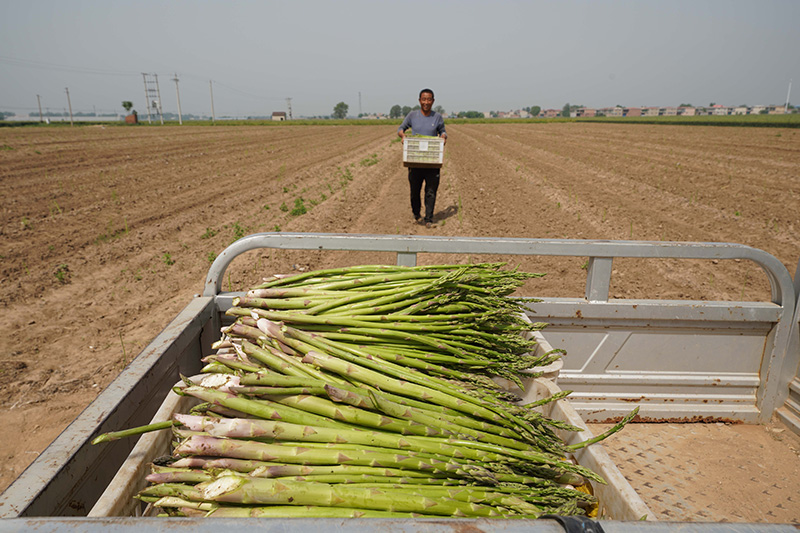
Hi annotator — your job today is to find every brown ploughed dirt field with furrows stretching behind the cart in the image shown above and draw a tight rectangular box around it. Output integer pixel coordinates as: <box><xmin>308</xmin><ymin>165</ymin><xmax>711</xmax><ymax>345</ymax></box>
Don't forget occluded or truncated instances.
<box><xmin>0</xmin><ymin>123</ymin><xmax>800</xmax><ymax>521</ymax></box>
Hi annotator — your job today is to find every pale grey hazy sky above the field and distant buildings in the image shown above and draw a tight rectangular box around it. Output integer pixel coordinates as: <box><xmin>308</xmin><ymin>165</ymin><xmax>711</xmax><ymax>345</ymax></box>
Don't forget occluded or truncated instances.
<box><xmin>0</xmin><ymin>0</ymin><xmax>800</xmax><ymax>117</ymax></box>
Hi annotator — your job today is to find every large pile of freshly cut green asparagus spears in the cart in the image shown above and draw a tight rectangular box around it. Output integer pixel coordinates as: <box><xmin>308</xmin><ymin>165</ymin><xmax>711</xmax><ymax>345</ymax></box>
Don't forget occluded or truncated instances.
<box><xmin>95</xmin><ymin>264</ymin><xmax>635</xmax><ymax>518</ymax></box>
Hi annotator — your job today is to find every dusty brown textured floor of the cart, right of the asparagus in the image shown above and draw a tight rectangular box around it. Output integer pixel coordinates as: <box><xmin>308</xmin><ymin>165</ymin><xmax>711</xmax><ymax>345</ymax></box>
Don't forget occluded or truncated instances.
<box><xmin>588</xmin><ymin>421</ymin><xmax>800</xmax><ymax>525</ymax></box>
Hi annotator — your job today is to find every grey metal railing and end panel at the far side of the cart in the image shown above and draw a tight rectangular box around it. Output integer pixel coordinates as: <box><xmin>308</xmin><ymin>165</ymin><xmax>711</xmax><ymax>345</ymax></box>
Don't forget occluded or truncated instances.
<box><xmin>204</xmin><ymin>233</ymin><xmax>795</xmax><ymax>422</ymax></box>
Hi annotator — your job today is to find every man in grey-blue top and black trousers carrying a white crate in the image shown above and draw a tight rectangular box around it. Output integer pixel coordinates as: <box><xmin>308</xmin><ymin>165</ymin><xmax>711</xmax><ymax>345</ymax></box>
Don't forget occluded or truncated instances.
<box><xmin>397</xmin><ymin>89</ymin><xmax>447</xmax><ymax>228</ymax></box>
